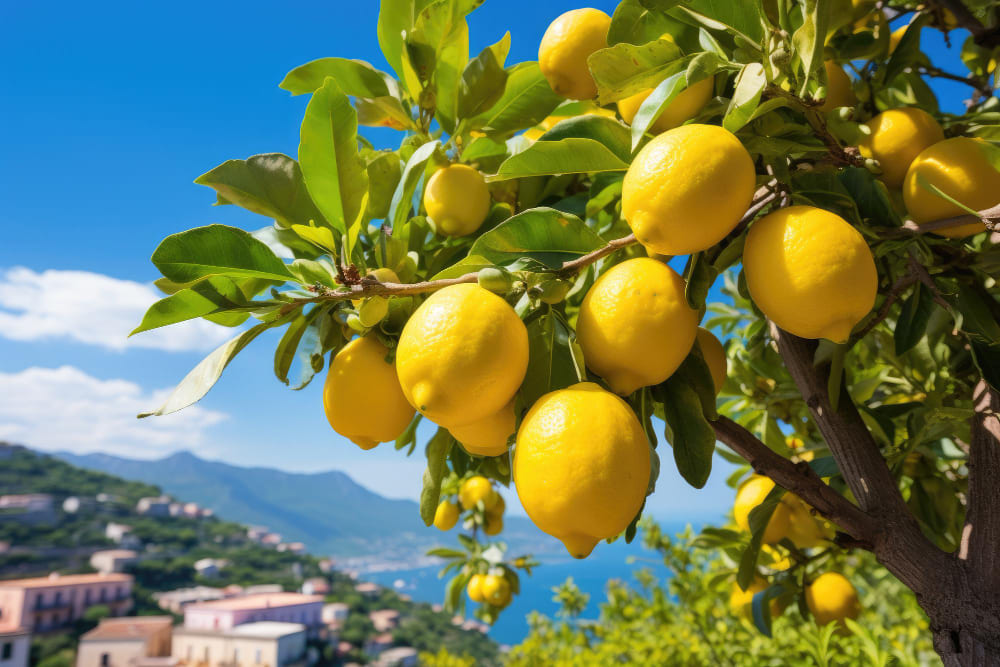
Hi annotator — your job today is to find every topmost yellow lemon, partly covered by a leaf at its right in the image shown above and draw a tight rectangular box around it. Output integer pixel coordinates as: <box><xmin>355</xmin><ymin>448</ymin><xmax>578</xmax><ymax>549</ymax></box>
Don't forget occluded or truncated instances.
<box><xmin>538</xmin><ymin>7</ymin><xmax>611</xmax><ymax>100</ymax></box>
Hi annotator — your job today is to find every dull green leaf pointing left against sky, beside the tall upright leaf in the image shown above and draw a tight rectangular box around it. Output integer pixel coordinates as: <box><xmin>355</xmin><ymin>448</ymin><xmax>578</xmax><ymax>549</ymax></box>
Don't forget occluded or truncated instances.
<box><xmin>194</xmin><ymin>153</ymin><xmax>325</xmax><ymax>227</ymax></box>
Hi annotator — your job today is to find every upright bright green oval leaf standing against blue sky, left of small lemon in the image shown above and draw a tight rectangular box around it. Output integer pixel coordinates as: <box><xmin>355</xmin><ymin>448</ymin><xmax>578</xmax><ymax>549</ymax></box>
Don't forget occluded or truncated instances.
<box><xmin>299</xmin><ymin>77</ymin><xmax>368</xmax><ymax>243</ymax></box>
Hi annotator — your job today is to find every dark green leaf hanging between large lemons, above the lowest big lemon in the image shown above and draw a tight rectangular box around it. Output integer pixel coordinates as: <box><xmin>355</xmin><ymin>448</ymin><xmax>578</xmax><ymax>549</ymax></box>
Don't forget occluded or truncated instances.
<box><xmin>521</xmin><ymin>310</ymin><xmax>580</xmax><ymax>405</ymax></box>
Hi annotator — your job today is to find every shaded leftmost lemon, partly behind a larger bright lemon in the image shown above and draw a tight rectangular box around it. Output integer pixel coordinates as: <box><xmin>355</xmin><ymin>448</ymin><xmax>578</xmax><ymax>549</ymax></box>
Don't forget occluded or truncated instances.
<box><xmin>323</xmin><ymin>336</ymin><xmax>413</xmax><ymax>449</ymax></box>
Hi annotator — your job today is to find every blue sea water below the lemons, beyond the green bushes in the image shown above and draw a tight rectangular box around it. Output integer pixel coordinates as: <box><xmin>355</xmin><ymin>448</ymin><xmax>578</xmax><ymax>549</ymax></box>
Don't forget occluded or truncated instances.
<box><xmin>362</xmin><ymin>522</ymin><xmax>701</xmax><ymax>645</ymax></box>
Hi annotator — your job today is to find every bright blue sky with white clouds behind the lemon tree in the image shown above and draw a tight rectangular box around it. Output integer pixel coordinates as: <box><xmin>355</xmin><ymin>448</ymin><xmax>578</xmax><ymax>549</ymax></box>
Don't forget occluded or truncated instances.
<box><xmin>0</xmin><ymin>0</ymin><xmax>968</xmax><ymax>519</ymax></box>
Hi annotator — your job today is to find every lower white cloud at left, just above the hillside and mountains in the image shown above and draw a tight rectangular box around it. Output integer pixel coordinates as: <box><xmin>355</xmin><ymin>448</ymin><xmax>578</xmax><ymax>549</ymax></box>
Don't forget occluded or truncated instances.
<box><xmin>0</xmin><ymin>366</ymin><xmax>226</xmax><ymax>458</ymax></box>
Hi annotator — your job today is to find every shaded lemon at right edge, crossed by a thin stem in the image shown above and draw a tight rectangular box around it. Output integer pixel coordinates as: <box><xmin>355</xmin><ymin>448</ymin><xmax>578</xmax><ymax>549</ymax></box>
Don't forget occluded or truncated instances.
<box><xmin>903</xmin><ymin>137</ymin><xmax>1000</xmax><ymax>239</ymax></box>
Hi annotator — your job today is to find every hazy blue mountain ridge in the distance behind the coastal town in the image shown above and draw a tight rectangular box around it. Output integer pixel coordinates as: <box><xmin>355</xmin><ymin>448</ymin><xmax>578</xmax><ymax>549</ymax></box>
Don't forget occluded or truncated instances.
<box><xmin>56</xmin><ymin>452</ymin><xmax>547</xmax><ymax>561</ymax></box>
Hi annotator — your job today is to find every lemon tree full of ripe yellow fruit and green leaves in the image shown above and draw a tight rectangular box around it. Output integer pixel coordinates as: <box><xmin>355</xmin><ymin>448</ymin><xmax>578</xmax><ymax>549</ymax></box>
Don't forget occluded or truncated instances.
<box><xmin>134</xmin><ymin>0</ymin><xmax>1000</xmax><ymax>664</ymax></box>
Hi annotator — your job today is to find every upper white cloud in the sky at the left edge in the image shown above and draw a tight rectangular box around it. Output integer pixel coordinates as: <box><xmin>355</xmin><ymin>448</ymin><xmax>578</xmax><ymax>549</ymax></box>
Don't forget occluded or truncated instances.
<box><xmin>0</xmin><ymin>267</ymin><xmax>235</xmax><ymax>351</ymax></box>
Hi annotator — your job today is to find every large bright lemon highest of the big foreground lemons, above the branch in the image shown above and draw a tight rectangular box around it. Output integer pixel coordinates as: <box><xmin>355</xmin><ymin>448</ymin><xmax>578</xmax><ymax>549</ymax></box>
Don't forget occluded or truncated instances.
<box><xmin>622</xmin><ymin>123</ymin><xmax>755</xmax><ymax>255</ymax></box>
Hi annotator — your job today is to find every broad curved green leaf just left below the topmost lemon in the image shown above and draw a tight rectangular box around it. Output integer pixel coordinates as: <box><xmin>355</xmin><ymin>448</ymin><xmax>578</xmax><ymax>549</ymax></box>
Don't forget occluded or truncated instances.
<box><xmin>468</xmin><ymin>61</ymin><xmax>562</xmax><ymax>135</ymax></box>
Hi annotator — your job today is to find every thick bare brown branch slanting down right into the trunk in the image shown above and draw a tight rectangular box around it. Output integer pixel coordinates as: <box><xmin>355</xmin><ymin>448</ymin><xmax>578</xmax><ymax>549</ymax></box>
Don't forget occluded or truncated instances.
<box><xmin>712</xmin><ymin>417</ymin><xmax>878</xmax><ymax>549</ymax></box>
